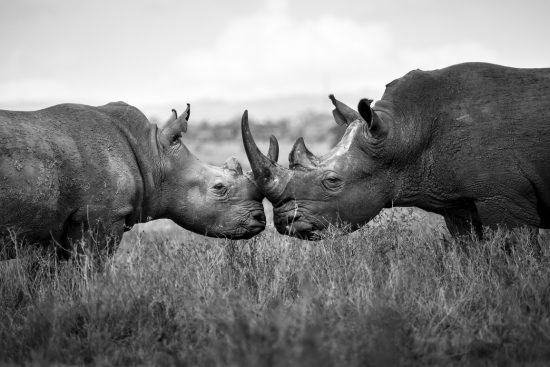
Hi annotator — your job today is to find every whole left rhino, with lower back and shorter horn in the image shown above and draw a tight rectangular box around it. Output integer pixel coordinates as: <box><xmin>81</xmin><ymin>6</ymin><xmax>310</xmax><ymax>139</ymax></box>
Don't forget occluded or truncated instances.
<box><xmin>0</xmin><ymin>102</ymin><xmax>265</xmax><ymax>255</ymax></box>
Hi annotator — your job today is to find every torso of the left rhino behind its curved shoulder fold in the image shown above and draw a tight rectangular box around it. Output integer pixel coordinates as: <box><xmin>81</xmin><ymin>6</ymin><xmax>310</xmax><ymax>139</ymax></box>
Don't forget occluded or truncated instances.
<box><xmin>0</xmin><ymin>104</ymin><xmax>141</xmax><ymax>239</ymax></box>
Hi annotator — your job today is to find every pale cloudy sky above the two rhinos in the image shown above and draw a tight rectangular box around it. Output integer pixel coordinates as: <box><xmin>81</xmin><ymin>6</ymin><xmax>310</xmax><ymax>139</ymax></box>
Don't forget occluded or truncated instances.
<box><xmin>0</xmin><ymin>0</ymin><xmax>550</xmax><ymax>118</ymax></box>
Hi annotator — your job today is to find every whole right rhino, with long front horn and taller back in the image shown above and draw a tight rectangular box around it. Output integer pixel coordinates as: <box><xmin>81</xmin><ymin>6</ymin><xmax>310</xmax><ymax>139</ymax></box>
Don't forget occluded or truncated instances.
<box><xmin>246</xmin><ymin>63</ymin><xmax>550</xmax><ymax>239</ymax></box>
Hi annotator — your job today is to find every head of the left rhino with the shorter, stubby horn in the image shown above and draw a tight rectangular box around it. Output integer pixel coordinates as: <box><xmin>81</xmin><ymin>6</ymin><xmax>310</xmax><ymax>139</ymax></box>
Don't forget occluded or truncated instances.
<box><xmin>155</xmin><ymin>106</ymin><xmax>265</xmax><ymax>239</ymax></box>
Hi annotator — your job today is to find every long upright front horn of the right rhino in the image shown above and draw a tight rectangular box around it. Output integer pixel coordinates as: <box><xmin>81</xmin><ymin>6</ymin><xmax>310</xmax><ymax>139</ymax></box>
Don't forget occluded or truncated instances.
<box><xmin>241</xmin><ymin>110</ymin><xmax>292</xmax><ymax>201</ymax></box>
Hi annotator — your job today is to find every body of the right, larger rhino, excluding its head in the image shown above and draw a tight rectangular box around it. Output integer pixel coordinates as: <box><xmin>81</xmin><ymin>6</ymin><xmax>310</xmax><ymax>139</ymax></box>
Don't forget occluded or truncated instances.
<box><xmin>374</xmin><ymin>63</ymin><xmax>550</xmax><ymax>234</ymax></box>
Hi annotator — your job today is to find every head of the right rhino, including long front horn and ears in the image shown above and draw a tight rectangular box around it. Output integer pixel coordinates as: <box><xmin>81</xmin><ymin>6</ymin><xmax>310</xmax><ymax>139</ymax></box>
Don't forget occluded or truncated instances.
<box><xmin>241</xmin><ymin>95</ymin><xmax>393</xmax><ymax>240</ymax></box>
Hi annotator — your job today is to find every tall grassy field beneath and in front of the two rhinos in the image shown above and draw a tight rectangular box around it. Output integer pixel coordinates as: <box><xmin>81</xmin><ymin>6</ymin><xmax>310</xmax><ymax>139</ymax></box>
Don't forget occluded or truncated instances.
<box><xmin>0</xmin><ymin>211</ymin><xmax>550</xmax><ymax>366</ymax></box>
